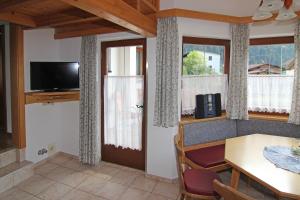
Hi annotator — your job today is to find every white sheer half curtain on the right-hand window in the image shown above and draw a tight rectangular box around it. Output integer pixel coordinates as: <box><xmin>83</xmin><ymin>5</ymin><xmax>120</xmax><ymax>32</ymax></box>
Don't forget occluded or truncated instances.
<box><xmin>248</xmin><ymin>75</ymin><xmax>294</xmax><ymax>113</ymax></box>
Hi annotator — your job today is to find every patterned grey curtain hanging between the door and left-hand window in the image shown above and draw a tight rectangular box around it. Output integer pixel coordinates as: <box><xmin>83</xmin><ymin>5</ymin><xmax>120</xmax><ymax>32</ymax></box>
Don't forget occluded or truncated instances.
<box><xmin>154</xmin><ymin>17</ymin><xmax>179</xmax><ymax>127</ymax></box>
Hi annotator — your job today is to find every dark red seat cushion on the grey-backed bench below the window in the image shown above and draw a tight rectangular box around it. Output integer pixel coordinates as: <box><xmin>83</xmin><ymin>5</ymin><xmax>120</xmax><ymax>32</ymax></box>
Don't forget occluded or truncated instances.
<box><xmin>186</xmin><ymin>144</ymin><xmax>225</xmax><ymax>168</ymax></box>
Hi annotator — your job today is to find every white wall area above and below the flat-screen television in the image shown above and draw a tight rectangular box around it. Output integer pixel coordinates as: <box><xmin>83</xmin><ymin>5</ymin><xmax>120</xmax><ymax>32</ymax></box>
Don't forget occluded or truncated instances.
<box><xmin>24</xmin><ymin>29</ymin><xmax>80</xmax><ymax>162</ymax></box>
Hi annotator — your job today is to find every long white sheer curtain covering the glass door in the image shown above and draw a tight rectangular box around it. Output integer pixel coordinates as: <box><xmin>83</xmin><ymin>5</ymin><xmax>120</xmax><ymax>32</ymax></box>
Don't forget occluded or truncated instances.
<box><xmin>104</xmin><ymin>76</ymin><xmax>144</xmax><ymax>150</ymax></box>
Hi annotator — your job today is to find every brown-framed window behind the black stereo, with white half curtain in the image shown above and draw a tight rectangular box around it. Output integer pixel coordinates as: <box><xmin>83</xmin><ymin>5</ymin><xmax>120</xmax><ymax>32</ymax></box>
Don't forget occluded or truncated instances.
<box><xmin>181</xmin><ymin>37</ymin><xmax>230</xmax><ymax>115</ymax></box>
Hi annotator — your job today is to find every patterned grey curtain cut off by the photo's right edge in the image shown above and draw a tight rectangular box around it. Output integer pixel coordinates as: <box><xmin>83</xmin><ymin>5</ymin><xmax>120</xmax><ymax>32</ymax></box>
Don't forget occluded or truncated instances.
<box><xmin>289</xmin><ymin>21</ymin><xmax>300</xmax><ymax>125</ymax></box>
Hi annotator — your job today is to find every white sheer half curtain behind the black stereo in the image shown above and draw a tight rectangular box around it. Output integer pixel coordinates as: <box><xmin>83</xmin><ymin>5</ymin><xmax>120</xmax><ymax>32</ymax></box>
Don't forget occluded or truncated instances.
<box><xmin>181</xmin><ymin>75</ymin><xmax>228</xmax><ymax>115</ymax></box>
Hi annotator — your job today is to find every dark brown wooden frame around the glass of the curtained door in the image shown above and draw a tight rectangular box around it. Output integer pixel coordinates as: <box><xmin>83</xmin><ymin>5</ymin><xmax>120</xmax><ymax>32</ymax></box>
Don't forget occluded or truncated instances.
<box><xmin>101</xmin><ymin>38</ymin><xmax>147</xmax><ymax>170</ymax></box>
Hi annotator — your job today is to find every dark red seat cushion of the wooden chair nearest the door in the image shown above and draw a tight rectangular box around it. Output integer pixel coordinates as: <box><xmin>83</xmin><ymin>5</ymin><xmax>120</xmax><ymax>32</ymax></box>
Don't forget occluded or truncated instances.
<box><xmin>183</xmin><ymin>169</ymin><xmax>221</xmax><ymax>196</ymax></box>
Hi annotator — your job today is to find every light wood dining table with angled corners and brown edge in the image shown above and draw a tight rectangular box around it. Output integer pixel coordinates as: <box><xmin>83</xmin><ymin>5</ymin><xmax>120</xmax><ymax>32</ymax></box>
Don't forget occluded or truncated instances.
<box><xmin>225</xmin><ymin>133</ymin><xmax>300</xmax><ymax>200</ymax></box>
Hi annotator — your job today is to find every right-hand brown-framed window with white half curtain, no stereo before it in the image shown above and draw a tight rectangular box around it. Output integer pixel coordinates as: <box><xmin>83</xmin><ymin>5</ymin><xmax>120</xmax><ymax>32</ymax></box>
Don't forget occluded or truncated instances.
<box><xmin>248</xmin><ymin>37</ymin><xmax>295</xmax><ymax>113</ymax></box>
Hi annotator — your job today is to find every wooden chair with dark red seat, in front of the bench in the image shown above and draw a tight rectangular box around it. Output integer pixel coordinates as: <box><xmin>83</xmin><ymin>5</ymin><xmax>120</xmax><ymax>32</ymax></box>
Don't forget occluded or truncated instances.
<box><xmin>174</xmin><ymin>135</ymin><xmax>220</xmax><ymax>200</ymax></box>
